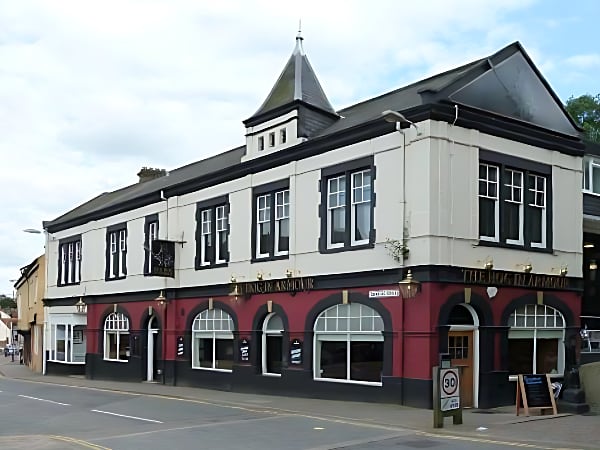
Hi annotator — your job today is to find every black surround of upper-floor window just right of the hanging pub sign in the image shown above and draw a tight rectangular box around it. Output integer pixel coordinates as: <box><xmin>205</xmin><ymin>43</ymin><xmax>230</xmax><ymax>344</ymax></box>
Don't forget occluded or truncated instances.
<box><xmin>194</xmin><ymin>195</ymin><xmax>230</xmax><ymax>270</ymax></box>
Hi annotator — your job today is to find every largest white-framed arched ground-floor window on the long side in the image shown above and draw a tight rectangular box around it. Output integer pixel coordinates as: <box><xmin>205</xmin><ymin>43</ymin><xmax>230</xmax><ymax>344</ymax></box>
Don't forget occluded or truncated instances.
<box><xmin>313</xmin><ymin>303</ymin><xmax>383</xmax><ymax>384</ymax></box>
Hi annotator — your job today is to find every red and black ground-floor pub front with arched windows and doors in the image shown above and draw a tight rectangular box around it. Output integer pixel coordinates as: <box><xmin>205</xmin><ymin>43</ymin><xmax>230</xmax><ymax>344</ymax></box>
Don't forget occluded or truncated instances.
<box><xmin>81</xmin><ymin>267</ymin><xmax>579</xmax><ymax>408</ymax></box>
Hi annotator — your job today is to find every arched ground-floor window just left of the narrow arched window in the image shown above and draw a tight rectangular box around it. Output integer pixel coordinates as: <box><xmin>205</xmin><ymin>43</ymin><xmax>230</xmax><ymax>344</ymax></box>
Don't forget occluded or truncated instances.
<box><xmin>192</xmin><ymin>308</ymin><xmax>234</xmax><ymax>371</ymax></box>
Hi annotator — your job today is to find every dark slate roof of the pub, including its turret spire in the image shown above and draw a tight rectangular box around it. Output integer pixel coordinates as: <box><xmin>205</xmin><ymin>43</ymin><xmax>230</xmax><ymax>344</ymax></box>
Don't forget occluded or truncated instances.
<box><xmin>44</xmin><ymin>38</ymin><xmax>580</xmax><ymax>231</ymax></box>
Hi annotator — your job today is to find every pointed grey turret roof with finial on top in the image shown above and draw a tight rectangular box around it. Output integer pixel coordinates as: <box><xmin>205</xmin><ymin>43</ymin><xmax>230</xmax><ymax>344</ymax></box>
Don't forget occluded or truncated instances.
<box><xmin>245</xmin><ymin>32</ymin><xmax>336</xmax><ymax>122</ymax></box>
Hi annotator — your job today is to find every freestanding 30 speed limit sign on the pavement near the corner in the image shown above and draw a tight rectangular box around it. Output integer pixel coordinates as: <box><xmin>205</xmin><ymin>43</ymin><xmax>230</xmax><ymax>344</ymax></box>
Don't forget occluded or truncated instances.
<box><xmin>432</xmin><ymin>354</ymin><xmax>462</xmax><ymax>428</ymax></box>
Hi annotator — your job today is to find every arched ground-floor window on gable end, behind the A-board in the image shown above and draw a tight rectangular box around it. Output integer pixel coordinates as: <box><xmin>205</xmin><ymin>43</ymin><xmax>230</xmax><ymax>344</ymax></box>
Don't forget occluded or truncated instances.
<box><xmin>508</xmin><ymin>304</ymin><xmax>565</xmax><ymax>375</ymax></box>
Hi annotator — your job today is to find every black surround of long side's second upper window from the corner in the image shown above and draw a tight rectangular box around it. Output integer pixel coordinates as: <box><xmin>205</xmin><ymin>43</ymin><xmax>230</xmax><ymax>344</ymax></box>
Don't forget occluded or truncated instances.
<box><xmin>250</xmin><ymin>178</ymin><xmax>292</xmax><ymax>263</ymax></box>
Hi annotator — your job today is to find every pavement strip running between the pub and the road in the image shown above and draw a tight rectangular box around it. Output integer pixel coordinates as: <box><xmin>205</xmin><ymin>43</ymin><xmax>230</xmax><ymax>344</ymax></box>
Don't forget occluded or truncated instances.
<box><xmin>0</xmin><ymin>356</ymin><xmax>600</xmax><ymax>450</ymax></box>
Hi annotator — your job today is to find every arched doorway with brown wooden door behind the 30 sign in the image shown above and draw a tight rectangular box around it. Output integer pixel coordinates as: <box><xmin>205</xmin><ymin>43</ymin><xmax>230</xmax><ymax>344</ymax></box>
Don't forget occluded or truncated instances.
<box><xmin>448</xmin><ymin>303</ymin><xmax>479</xmax><ymax>408</ymax></box>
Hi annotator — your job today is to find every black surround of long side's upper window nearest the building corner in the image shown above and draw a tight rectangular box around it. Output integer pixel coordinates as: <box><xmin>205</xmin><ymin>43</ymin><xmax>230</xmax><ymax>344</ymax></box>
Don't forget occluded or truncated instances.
<box><xmin>319</xmin><ymin>156</ymin><xmax>376</xmax><ymax>253</ymax></box>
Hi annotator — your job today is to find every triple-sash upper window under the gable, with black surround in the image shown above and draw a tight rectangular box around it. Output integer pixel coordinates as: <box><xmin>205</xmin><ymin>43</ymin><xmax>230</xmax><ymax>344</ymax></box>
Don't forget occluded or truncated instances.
<box><xmin>478</xmin><ymin>151</ymin><xmax>552</xmax><ymax>249</ymax></box>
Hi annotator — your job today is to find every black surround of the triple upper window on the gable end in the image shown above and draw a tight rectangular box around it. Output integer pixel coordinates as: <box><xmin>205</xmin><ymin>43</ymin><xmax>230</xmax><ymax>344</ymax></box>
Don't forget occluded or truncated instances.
<box><xmin>479</xmin><ymin>149</ymin><xmax>553</xmax><ymax>253</ymax></box>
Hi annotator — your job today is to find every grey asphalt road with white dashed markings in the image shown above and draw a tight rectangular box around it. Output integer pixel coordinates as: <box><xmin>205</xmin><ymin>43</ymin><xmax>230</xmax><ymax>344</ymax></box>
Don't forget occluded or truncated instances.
<box><xmin>0</xmin><ymin>378</ymin><xmax>580</xmax><ymax>450</ymax></box>
